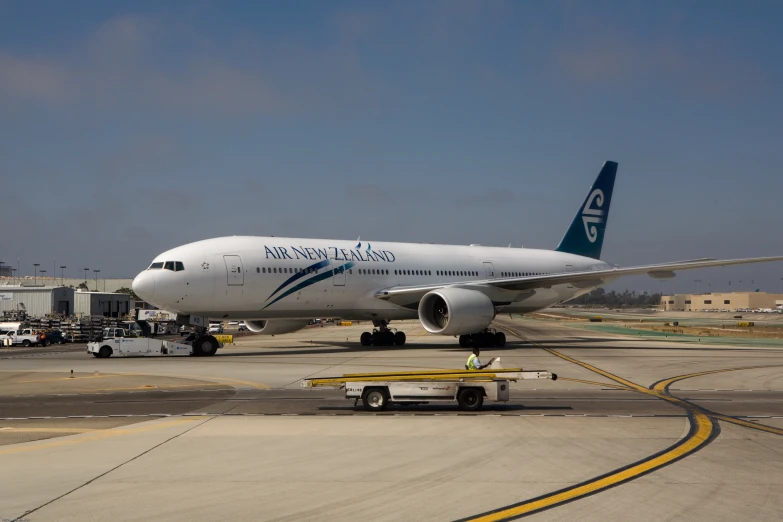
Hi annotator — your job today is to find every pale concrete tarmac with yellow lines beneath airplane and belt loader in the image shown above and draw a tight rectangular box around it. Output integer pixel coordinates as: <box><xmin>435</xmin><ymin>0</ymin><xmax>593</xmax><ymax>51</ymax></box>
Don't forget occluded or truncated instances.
<box><xmin>0</xmin><ymin>317</ymin><xmax>783</xmax><ymax>521</ymax></box>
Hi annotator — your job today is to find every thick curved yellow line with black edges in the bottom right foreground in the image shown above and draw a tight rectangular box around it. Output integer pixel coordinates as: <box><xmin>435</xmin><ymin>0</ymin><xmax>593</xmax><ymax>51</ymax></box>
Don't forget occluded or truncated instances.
<box><xmin>471</xmin><ymin>413</ymin><xmax>713</xmax><ymax>522</ymax></box>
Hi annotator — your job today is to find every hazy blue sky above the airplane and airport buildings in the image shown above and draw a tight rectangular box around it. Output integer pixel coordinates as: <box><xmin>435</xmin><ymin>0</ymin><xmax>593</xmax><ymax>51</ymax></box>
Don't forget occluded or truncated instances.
<box><xmin>0</xmin><ymin>0</ymin><xmax>783</xmax><ymax>292</ymax></box>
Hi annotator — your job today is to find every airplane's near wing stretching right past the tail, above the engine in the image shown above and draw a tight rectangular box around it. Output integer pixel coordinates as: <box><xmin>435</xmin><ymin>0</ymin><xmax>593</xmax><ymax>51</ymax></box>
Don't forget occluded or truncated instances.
<box><xmin>375</xmin><ymin>256</ymin><xmax>783</xmax><ymax>306</ymax></box>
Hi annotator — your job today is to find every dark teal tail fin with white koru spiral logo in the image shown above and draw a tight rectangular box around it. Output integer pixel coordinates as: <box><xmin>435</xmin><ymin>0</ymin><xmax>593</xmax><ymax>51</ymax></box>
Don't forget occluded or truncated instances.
<box><xmin>557</xmin><ymin>161</ymin><xmax>617</xmax><ymax>259</ymax></box>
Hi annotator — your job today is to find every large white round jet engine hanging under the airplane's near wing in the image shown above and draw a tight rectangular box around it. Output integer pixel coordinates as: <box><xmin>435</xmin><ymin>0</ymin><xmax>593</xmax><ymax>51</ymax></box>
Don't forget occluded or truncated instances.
<box><xmin>419</xmin><ymin>288</ymin><xmax>495</xmax><ymax>335</ymax></box>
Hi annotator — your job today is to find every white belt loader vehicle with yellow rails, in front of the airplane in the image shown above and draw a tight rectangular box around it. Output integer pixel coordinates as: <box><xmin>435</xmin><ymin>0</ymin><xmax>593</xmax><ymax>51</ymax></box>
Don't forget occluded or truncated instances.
<box><xmin>302</xmin><ymin>368</ymin><xmax>557</xmax><ymax>411</ymax></box>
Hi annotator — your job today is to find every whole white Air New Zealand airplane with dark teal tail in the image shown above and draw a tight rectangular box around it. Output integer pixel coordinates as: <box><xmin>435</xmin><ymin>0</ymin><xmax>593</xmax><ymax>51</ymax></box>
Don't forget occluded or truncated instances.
<box><xmin>133</xmin><ymin>161</ymin><xmax>783</xmax><ymax>355</ymax></box>
